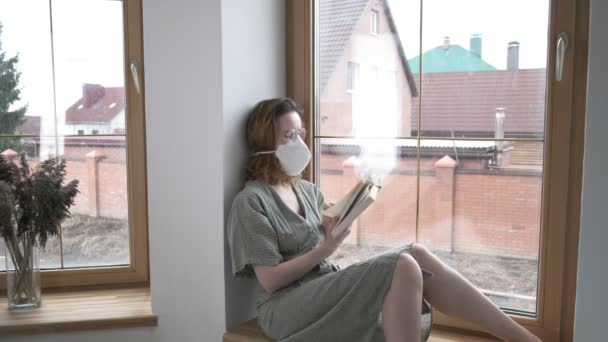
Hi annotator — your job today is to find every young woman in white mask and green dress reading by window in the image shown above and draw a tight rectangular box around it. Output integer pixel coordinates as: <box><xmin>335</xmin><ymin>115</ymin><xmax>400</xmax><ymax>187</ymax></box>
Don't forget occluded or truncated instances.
<box><xmin>228</xmin><ymin>98</ymin><xmax>540</xmax><ymax>342</ymax></box>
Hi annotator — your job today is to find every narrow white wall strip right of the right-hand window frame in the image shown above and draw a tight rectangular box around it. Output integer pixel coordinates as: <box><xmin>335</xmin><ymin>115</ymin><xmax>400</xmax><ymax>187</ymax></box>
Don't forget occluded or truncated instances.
<box><xmin>574</xmin><ymin>0</ymin><xmax>608</xmax><ymax>342</ymax></box>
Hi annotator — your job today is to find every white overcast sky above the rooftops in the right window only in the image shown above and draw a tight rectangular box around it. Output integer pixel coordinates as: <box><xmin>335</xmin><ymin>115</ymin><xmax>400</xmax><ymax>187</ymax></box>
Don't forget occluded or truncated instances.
<box><xmin>389</xmin><ymin>0</ymin><xmax>549</xmax><ymax>69</ymax></box>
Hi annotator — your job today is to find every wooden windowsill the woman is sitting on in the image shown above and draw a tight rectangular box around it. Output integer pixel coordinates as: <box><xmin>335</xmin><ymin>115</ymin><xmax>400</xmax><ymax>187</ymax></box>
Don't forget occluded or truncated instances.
<box><xmin>224</xmin><ymin>319</ymin><xmax>498</xmax><ymax>342</ymax></box>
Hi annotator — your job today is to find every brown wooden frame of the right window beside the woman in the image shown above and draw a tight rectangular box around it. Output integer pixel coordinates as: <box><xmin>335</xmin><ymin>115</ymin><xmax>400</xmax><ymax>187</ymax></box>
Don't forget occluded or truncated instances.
<box><xmin>286</xmin><ymin>0</ymin><xmax>589</xmax><ymax>341</ymax></box>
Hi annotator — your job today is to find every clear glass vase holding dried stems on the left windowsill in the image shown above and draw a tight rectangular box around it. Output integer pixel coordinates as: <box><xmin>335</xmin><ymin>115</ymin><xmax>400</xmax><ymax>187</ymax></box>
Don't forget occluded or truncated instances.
<box><xmin>5</xmin><ymin>233</ymin><xmax>41</xmax><ymax>310</ymax></box>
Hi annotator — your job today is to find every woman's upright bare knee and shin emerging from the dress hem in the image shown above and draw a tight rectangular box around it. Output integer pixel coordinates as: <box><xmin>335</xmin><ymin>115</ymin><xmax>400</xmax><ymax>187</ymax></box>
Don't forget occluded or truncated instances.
<box><xmin>382</xmin><ymin>254</ymin><xmax>422</xmax><ymax>342</ymax></box>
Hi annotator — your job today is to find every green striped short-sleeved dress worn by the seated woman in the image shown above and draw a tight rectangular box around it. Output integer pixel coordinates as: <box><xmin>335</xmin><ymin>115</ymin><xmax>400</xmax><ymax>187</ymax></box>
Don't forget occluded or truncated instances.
<box><xmin>227</xmin><ymin>180</ymin><xmax>432</xmax><ymax>342</ymax></box>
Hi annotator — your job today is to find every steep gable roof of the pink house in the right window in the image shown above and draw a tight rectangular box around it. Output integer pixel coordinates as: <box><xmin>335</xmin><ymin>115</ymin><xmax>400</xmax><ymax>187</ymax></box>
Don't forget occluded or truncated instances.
<box><xmin>319</xmin><ymin>0</ymin><xmax>417</xmax><ymax>96</ymax></box>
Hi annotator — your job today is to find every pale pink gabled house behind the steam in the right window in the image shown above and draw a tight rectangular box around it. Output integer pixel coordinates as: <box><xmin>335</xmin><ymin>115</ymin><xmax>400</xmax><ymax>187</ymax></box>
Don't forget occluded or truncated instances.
<box><xmin>318</xmin><ymin>0</ymin><xmax>417</xmax><ymax>136</ymax></box>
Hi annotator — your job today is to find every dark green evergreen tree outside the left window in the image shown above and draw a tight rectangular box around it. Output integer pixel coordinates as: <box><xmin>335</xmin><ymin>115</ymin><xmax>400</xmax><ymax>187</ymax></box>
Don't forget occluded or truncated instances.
<box><xmin>0</xmin><ymin>23</ymin><xmax>27</xmax><ymax>152</ymax></box>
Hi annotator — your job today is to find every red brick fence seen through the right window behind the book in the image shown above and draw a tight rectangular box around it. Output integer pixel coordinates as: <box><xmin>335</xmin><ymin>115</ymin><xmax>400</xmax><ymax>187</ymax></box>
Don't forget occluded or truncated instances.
<box><xmin>319</xmin><ymin>154</ymin><xmax>542</xmax><ymax>258</ymax></box>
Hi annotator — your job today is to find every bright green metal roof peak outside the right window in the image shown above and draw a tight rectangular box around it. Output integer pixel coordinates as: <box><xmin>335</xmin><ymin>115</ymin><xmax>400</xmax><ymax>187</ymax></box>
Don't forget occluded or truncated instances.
<box><xmin>408</xmin><ymin>45</ymin><xmax>496</xmax><ymax>74</ymax></box>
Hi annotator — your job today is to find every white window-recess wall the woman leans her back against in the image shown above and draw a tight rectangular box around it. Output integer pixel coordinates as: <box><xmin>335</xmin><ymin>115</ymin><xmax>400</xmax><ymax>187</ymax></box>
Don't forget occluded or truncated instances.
<box><xmin>222</xmin><ymin>0</ymin><xmax>286</xmax><ymax>327</ymax></box>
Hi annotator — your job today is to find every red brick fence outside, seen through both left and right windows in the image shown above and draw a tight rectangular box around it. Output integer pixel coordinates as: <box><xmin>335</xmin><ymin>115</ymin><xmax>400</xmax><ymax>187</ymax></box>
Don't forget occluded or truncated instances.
<box><xmin>3</xmin><ymin>147</ymin><xmax>542</xmax><ymax>258</ymax></box>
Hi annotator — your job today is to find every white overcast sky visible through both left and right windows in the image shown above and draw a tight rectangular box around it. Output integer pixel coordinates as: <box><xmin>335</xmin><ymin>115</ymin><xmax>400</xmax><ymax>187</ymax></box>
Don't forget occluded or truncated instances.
<box><xmin>0</xmin><ymin>0</ymin><xmax>549</xmax><ymax>129</ymax></box>
